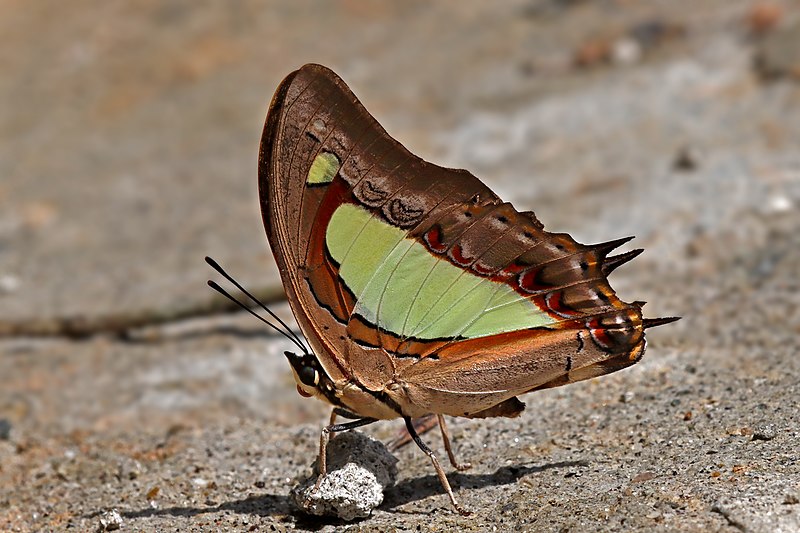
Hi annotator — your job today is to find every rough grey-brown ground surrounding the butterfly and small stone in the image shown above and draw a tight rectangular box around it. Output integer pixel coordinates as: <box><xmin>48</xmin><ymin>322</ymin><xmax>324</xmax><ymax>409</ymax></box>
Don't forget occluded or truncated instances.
<box><xmin>0</xmin><ymin>0</ymin><xmax>800</xmax><ymax>532</ymax></box>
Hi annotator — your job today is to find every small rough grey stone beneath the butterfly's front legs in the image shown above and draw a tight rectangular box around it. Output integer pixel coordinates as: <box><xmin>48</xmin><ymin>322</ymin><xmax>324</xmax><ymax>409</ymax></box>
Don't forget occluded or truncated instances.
<box><xmin>292</xmin><ymin>431</ymin><xmax>397</xmax><ymax>520</ymax></box>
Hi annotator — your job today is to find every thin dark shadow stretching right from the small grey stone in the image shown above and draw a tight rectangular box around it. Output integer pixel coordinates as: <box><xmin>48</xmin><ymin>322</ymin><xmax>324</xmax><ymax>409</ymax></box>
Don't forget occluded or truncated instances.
<box><xmin>381</xmin><ymin>460</ymin><xmax>588</xmax><ymax>510</ymax></box>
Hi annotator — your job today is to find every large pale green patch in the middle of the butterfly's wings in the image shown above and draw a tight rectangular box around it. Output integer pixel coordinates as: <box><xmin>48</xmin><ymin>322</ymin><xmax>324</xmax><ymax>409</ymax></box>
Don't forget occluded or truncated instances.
<box><xmin>325</xmin><ymin>204</ymin><xmax>553</xmax><ymax>339</ymax></box>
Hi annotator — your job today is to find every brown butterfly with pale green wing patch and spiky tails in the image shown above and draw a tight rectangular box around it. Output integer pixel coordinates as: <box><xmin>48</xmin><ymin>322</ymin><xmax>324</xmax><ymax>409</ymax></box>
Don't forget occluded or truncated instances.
<box><xmin>209</xmin><ymin>64</ymin><xmax>677</xmax><ymax>514</ymax></box>
